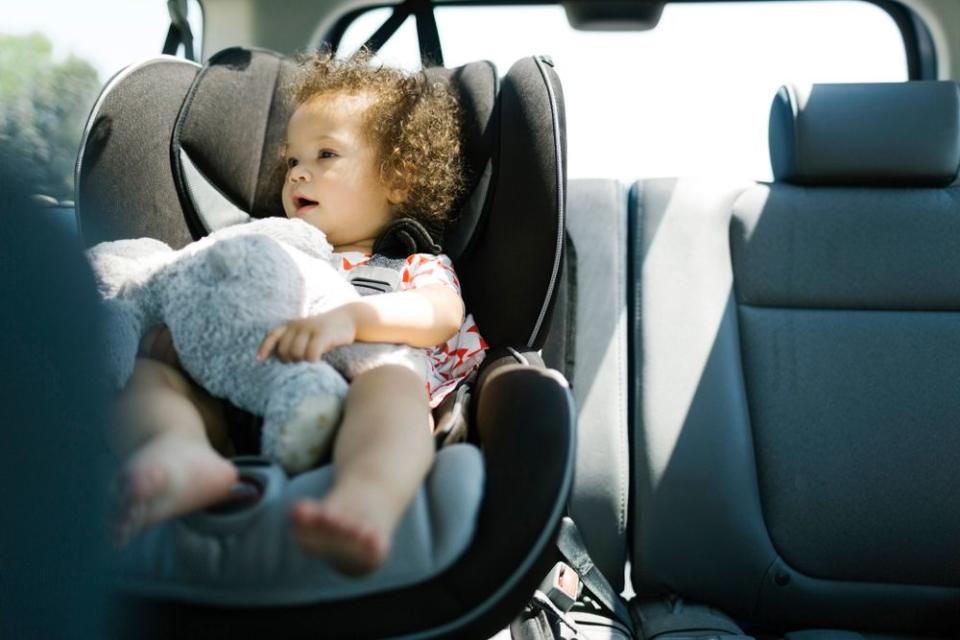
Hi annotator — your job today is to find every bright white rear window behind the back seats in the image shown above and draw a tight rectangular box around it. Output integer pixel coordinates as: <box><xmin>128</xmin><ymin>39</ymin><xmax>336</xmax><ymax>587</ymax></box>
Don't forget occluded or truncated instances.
<box><xmin>340</xmin><ymin>0</ymin><xmax>908</xmax><ymax>180</ymax></box>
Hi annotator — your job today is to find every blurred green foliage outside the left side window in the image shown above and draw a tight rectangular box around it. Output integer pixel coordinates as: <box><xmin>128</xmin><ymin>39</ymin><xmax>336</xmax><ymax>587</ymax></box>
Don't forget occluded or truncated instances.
<box><xmin>0</xmin><ymin>33</ymin><xmax>101</xmax><ymax>200</ymax></box>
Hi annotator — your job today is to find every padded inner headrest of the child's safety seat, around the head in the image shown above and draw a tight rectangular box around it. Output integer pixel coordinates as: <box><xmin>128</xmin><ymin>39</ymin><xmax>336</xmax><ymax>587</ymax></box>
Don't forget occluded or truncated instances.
<box><xmin>172</xmin><ymin>47</ymin><xmax>497</xmax><ymax>259</ymax></box>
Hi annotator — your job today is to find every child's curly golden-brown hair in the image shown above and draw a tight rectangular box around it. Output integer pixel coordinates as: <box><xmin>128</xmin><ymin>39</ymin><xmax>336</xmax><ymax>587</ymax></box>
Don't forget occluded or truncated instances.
<box><xmin>287</xmin><ymin>49</ymin><xmax>464</xmax><ymax>231</ymax></box>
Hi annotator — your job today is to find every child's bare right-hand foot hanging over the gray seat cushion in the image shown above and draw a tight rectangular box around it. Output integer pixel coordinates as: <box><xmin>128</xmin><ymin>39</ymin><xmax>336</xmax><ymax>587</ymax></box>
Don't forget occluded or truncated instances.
<box><xmin>290</xmin><ymin>491</ymin><xmax>396</xmax><ymax>576</ymax></box>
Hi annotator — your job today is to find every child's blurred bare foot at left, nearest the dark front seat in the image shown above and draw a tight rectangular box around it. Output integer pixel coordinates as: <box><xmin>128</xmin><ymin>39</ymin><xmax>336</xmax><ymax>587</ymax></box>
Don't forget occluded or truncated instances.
<box><xmin>114</xmin><ymin>435</ymin><xmax>237</xmax><ymax>545</ymax></box>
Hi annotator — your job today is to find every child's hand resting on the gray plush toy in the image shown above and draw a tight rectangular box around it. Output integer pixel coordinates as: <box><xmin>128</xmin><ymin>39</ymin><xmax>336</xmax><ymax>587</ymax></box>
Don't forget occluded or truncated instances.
<box><xmin>257</xmin><ymin>305</ymin><xmax>357</xmax><ymax>362</ymax></box>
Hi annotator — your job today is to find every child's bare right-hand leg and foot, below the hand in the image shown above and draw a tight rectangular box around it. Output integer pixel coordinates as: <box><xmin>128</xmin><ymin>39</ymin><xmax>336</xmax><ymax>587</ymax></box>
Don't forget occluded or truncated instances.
<box><xmin>291</xmin><ymin>365</ymin><xmax>434</xmax><ymax>575</ymax></box>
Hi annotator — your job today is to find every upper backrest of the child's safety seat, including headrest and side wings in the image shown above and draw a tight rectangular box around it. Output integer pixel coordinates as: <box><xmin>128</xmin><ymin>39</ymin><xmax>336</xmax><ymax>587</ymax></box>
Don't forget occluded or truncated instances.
<box><xmin>77</xmin><ymin>48</ymin><xmax>566</xmax><ymax>349</ymax></box>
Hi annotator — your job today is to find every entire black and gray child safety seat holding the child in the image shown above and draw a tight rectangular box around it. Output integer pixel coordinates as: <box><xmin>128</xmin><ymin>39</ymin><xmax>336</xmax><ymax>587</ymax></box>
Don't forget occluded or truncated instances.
<box><xmin>77</xmin><ymin>49</ymin><xmax>573</xmax><ymax>638</ymax></box>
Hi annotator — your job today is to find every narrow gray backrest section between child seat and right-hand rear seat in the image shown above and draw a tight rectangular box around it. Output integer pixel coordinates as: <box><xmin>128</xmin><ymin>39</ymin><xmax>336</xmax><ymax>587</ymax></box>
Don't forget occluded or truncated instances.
<box><xmin>543</xmin><ymin>179</ymin><xmax>630</xmax><ymax>593</ymax></box>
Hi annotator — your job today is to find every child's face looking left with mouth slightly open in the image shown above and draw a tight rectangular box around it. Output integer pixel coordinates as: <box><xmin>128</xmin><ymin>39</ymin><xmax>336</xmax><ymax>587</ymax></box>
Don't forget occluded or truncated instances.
<box><xmin>282</xmin><ymin>94</ymin><xmax>402</xmax><ymax>251</ymax></box>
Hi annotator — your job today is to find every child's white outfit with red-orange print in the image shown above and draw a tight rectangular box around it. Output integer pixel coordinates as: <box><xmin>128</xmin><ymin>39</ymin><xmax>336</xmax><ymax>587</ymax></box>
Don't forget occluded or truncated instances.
<box><xmin>337</xmin><ymin>252</ymin><xmax>487</xmax><ymax>407</ymax></box>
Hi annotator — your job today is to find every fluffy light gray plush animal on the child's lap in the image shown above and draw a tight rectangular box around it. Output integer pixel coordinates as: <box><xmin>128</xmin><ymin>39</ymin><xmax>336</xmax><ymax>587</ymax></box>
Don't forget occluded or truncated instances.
<box><xmin>88</xmin><ymin>218</ymin><xmax>416</xmax><ymax>473</ymax></box>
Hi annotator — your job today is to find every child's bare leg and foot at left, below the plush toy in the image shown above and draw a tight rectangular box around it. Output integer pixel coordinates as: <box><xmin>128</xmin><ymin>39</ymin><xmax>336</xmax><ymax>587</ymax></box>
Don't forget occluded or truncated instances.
<box><xmin>113</xmin><ymin>359</ymin><xmax>237</xmax><ymax>541</ymax></box>
